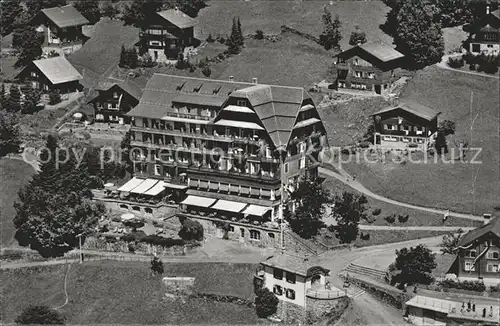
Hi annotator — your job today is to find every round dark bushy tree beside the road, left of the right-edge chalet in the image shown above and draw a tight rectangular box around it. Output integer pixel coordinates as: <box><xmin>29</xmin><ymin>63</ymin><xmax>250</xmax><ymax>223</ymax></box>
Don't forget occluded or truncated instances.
<box><xmin>394</xmin><ymin>244</ymin><xmax>437</xmax><ymax>285</ymax></box>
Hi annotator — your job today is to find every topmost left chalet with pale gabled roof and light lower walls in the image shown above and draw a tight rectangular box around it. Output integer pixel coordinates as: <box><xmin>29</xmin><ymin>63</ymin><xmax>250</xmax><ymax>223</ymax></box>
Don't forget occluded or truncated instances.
<box><xmin>31</xmin><ymin>5</ymin><xmax>89</xmax><ymax>54</ymax></box>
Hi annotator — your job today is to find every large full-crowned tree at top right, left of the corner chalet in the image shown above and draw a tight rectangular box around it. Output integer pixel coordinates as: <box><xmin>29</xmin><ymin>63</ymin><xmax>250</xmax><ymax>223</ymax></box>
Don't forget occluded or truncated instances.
<box><xmin>394</xmin><ymin>0</ymin><xmax>444</xmax><ymax>68</ymax></box>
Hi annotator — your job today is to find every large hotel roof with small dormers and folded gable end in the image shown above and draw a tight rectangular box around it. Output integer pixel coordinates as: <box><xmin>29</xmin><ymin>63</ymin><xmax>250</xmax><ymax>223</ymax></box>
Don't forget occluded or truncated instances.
<box><xmin>127</xmin><ymin>74</ymin><xmax>311</xmax><ymax>147</ymax></box>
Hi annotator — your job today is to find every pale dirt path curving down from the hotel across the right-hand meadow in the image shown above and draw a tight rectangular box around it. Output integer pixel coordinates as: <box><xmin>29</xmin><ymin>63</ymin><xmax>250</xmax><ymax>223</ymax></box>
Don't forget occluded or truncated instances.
<box><xmin>319</xmin><ymin>167</ymin><xmax>484</xmax><ymax>221</ymax></box>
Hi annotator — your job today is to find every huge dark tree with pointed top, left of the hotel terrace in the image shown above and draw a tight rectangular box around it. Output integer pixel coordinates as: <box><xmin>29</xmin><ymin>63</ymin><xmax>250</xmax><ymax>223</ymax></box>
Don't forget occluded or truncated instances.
<box><xmin>14</xmin><ymin>136</ymin><xmax>106</xmax><ymax>257</ymax></box>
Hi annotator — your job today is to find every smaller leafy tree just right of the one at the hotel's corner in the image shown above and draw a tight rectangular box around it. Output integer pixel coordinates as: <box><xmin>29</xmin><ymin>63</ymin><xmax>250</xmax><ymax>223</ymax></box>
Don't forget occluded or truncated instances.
<box><xmin>332</xmin><ymin>192</ymin><xmax>368</xmax><ymax>243</ymax></box>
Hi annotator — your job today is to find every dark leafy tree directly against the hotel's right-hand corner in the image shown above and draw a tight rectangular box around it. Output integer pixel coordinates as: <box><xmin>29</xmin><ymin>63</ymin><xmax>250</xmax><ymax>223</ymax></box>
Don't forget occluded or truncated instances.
<box><xmin>285</xmin><ymin>179</ymin><xmax>332</xmax><ymax>239</ymax></box>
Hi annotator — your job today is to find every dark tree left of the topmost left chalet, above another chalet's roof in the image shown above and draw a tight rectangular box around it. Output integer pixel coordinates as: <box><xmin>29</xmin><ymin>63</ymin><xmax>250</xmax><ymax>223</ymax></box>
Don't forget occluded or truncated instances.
<box><xmin>12</xmin><ymin>25</ymin><xmax>43</xmax><ymax>67</ymax></box>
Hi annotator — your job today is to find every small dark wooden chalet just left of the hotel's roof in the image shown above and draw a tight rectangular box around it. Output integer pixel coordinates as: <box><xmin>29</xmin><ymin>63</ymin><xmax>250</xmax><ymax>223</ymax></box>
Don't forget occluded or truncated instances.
<box><xmin>88</xmin><ymin>81</ymin><xmax>142</xmax><ymax>124</ymax></box>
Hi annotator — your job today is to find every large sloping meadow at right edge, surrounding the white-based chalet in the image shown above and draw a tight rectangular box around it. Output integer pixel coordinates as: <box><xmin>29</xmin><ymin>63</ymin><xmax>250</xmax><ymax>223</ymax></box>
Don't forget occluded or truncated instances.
<box><xmin>344</xmin><ymin>67</ymin><xmax>500</xmax><ymax>214</ymax></box>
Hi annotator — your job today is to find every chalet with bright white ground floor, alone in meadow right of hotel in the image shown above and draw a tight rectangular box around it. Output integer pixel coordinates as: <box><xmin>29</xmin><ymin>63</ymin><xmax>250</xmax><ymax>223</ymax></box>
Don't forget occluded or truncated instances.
<box><xmin>371</xmin><ymin>101</ymin><xmax>440</xmax><ymax>150</ymax></box>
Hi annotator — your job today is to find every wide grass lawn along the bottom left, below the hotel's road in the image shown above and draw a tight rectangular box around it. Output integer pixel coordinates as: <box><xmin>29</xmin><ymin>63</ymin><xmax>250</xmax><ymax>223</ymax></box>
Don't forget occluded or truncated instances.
<box><xmin>0</xmin><ymin>261</ymin><xmax>264</xmax><ymax>324</ymax></box>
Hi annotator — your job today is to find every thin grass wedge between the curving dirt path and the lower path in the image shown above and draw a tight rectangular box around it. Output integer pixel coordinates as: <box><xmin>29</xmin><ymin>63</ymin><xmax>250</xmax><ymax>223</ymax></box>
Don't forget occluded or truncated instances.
<box><xmin>323</xmin><ymin>177</ymin><xmax>483</xmax><ymax>227</ymax></box>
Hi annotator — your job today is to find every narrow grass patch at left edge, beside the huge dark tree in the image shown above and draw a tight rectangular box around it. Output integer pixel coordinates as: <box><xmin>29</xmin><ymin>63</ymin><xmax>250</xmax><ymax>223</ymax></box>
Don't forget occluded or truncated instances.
<box><xmin>0</xmin><ymin>158</ymin><xmax>34</xmax><ymax>247</ymax></box>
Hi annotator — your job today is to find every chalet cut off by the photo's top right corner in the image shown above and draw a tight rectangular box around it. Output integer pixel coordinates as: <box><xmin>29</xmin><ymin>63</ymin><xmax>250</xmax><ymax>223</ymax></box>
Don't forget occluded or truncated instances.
<box><xmin>467</xmin><ymin>6</ymin><xmax>500</xmax><ymax>55</ymax></box>
